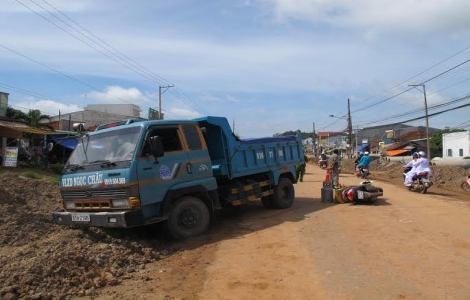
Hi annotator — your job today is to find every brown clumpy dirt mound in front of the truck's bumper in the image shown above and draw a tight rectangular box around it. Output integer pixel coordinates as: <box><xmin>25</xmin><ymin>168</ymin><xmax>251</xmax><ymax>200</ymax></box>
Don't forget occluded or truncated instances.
<box><xmin>0</xmin><ymin>172</ymin><xmax>171</xmax><ymax>299</ymax></box>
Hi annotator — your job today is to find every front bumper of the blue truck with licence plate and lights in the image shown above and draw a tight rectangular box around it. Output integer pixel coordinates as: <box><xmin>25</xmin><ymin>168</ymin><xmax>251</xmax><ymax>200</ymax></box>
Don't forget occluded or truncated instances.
<box><xmin>52</xmin><ymin>209</ymin><xmax>148</xmax><ymax>228</ymax></box>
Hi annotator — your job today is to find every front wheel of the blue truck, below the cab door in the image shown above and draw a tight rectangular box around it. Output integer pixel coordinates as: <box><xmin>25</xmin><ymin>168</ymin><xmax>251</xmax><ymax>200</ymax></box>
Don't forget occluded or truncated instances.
<box><xmin>168</xmin><ymin>196</ymin><xmax>210</xmax><ymax>240</ymax></box>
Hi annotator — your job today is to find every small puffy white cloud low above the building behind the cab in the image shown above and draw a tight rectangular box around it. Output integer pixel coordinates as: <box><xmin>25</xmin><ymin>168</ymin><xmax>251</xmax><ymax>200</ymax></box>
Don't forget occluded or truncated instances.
<box><xmin>82</xmin><ymin>86</ymin><xmax>152</xmax><ymax>105</ymax></box>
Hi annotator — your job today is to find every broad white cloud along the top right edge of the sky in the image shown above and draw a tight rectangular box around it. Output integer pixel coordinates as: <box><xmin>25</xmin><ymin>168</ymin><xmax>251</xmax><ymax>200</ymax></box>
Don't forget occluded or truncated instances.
<box><xmin>254</xmin><ymin>0</ymin><xmax>470</xmax><ymax>33</ymax></box>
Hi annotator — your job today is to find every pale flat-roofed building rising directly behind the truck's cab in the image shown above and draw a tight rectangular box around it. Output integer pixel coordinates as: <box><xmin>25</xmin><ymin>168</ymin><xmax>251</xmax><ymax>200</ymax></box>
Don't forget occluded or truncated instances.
<box><xmin>49</xmin><ymin>104</ymin><xmax>143</xmax><ymax>131</ymax></box>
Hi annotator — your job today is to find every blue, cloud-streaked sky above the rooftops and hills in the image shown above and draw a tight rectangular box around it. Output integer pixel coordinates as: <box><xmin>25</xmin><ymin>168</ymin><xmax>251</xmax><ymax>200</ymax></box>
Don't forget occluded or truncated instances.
<box><xmin>0</xmin><ymin>0</ymin><xmax>470</xmax><ymax>138</ymax></box>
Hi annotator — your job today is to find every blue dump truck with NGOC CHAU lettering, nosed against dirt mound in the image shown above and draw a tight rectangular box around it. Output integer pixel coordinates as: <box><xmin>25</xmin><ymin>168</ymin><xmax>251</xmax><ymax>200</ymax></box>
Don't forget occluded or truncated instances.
<box><xmin>53</xmin><ymin>116</ymin><xmax>304</xmax><ymax>239</ymax></box>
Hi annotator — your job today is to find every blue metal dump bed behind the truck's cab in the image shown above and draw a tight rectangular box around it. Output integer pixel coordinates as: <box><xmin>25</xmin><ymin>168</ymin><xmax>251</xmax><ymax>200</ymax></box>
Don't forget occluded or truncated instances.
<box><xmin>195</xmin><ymin>117</ymin><xmax>304</xmax><ymax>178</ymax></box>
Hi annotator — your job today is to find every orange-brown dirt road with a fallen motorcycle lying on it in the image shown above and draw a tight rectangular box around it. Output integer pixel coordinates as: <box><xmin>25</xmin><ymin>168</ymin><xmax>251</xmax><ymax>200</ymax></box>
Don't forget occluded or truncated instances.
<box><xmin>99</xmin><ymin>164</ymin><xmax>470</xmax><ymax>300</ymax></box>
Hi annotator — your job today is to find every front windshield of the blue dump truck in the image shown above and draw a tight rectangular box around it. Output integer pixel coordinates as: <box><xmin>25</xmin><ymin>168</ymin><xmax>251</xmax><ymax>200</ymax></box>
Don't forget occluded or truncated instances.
<box><xmin>67</xmin><ymin>127</ymin><xmax>142</xmax><ymax>166</ymax></box>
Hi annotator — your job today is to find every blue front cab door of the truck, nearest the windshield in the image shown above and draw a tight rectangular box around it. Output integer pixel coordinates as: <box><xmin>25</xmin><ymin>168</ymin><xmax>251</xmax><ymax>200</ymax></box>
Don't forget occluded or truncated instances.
<box><xmin>137</xmin><ymin>125</ymin><xmax>193</xmax><ymax>212</ymax></box>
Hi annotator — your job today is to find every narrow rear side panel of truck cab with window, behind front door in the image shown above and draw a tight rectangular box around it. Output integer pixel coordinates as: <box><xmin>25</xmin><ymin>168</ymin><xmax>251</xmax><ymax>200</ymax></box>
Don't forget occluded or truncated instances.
<box><xmin>182</xmin><ymin>125</ymin><xmax>212</xmax><ymax>180</ymax></box>
